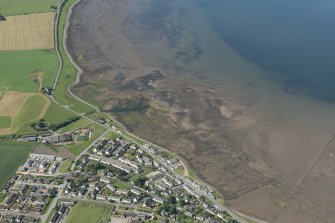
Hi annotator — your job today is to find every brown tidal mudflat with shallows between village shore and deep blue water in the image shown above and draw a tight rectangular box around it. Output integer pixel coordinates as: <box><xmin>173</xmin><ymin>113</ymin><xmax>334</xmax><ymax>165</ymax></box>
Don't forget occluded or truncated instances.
<box><xmin>67</xmin><ymin>0</ymin><xmax>335</xmax><ymax>223</ymax></box>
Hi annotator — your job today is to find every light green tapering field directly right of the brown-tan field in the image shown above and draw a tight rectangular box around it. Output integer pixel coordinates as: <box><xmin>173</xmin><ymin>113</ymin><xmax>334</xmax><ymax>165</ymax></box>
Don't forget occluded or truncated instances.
<box><xmin>11</xmin><ymin>94</ymin><xmax>49</xmax><ymax>132</ymax></box>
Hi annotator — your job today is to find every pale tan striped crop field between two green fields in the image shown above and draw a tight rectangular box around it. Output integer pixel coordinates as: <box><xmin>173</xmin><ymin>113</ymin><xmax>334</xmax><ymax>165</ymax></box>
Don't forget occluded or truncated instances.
<box><xmin>0</xmin><ymin>12</ymin><xmax>55</xmax><ymax>50</ymax></box>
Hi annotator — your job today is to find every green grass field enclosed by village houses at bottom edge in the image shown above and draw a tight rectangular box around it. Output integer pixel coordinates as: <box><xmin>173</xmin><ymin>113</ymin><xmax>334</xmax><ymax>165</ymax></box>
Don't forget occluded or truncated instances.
<box><xmin>67</xmin><ymin>202</ymin><xmax>113</xmax><ymax>223</ymax></box>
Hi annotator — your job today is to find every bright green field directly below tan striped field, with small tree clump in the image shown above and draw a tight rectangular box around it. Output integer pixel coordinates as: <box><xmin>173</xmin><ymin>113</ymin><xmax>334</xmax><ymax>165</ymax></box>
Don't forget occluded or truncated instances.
<box><xmin>0</xmin><ymin>50</ymin><xmax>58</xmax><ymax>92</ymax></box>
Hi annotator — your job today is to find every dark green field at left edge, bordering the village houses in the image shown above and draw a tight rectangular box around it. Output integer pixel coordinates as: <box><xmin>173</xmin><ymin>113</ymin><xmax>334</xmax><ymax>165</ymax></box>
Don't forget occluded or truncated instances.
<box><xmin>0</xmin><ymin>141</ymin><xmax>36</xmax><ymax>188</ymax></box>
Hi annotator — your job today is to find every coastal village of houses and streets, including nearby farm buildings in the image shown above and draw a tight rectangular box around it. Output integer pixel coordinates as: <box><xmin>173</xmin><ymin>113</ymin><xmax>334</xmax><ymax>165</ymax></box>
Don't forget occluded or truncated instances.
<box><xmin>0</xmin><ymin>121</ymin><xmax>242</xmax><ymax>223</ymax></box>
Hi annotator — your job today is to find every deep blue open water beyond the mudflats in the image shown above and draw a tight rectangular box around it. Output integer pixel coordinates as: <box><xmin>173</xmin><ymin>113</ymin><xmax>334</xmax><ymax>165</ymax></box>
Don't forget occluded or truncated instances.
<box><xmin>198</xmin><ymin>0</ymin><xmax>335</xmax><ymax>102</ymax></box>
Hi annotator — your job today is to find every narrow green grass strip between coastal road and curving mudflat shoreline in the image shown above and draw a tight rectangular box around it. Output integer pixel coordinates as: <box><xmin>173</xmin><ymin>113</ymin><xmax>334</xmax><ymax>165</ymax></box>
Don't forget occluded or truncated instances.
<box><xmin>55</xmin><ymin>0</ymin><xmax>94</xmax><ymax>114</ymax></box>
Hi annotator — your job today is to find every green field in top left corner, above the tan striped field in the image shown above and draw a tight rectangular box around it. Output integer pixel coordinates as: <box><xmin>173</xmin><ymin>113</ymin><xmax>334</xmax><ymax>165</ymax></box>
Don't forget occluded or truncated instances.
<box><xmin>0</xmin><ymin>0</ymin><xmax>59</xmax><ymax>16</ymax></box>
